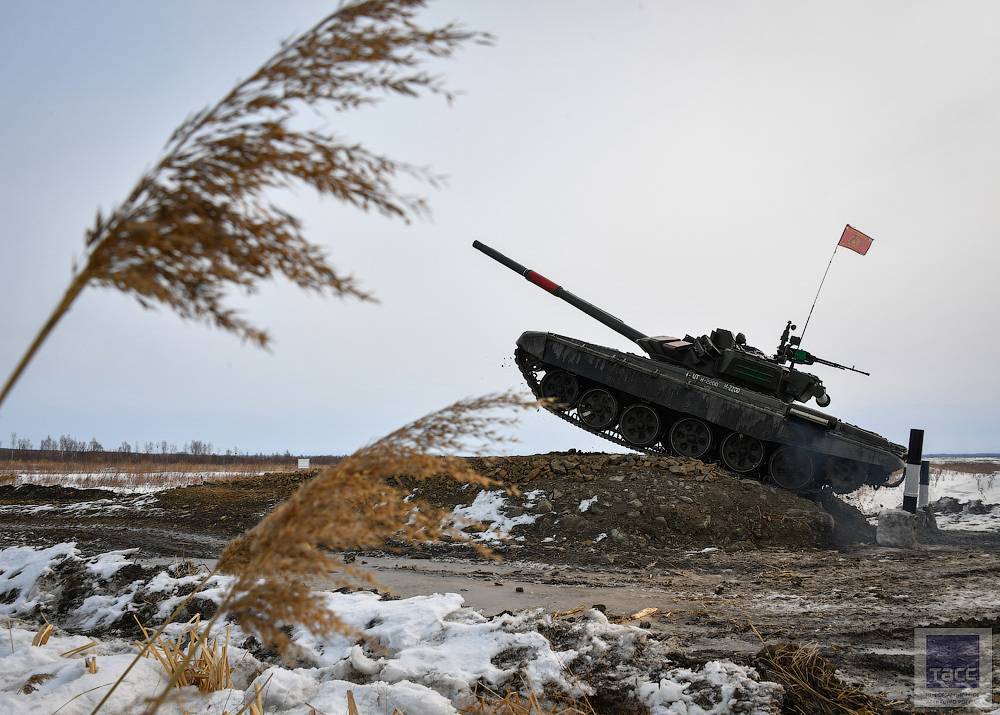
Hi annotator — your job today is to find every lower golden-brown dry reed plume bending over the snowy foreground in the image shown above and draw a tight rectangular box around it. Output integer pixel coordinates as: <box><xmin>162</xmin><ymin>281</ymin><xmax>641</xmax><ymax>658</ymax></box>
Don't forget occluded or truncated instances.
<box><xmin>93</xmin><ymin>393</ymin><xmax>537</xmax><ymax>713</ymax></box>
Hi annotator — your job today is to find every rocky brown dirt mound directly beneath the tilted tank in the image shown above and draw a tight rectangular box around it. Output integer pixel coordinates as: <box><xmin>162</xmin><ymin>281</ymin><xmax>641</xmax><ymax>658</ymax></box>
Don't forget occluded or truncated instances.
<box><xmin>402</xmin><ymin>452</ymin><xmax>835</xmax><ymax>565</ymax></box>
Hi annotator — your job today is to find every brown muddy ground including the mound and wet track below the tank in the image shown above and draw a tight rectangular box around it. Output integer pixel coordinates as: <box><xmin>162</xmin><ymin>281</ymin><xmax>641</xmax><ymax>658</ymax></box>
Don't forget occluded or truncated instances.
<box><xmin>0</xmin><ymin>453</ymin><xmax>1000</xmax><ymax>709</ymax></box>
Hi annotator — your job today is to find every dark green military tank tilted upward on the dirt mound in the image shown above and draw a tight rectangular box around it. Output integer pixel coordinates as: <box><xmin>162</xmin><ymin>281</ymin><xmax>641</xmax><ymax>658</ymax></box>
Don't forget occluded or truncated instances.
<box><xmin>472</xmin><ymin>241</ymin><xmax>906</xmax><ymax>494</ymax></box>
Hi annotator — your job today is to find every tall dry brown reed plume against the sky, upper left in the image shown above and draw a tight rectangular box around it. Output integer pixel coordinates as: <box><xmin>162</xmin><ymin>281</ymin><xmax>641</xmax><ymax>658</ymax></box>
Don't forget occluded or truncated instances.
<box><xmin>0</xmin><ymin>0</ymin><xmax>490</xmax><ymax>412</ymax></box>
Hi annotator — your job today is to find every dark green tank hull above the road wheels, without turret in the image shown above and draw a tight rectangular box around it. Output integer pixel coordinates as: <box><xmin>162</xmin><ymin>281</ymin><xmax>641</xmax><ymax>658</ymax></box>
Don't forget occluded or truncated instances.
<box><xmin>517</xmin><ymin>332</ymin><xmax>905</xmax><ymax>492</ymax></box>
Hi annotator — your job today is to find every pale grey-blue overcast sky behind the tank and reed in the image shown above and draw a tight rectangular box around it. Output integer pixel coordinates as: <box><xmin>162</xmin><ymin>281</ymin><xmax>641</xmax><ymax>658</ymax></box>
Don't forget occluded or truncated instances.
<box><xmin>0</xmin><ymin>0</ymin><xmax>1000</xmax><ymax>453</ymax></box>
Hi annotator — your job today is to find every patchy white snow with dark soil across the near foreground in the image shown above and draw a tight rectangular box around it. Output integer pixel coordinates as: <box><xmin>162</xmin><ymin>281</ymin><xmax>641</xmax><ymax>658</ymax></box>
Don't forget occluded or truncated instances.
<box><xmin>0</xmin><ymin>544</ymin><xmax>778</xmax><ymax>715</ymax></box>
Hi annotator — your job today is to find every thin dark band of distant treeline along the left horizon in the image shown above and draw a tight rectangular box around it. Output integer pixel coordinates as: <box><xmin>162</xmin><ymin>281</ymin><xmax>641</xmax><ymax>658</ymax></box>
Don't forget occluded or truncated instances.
<box><xmin>0</xmin><ymin>447</ymin><xmax>343</xmax><ymax>468</ymax></box>
